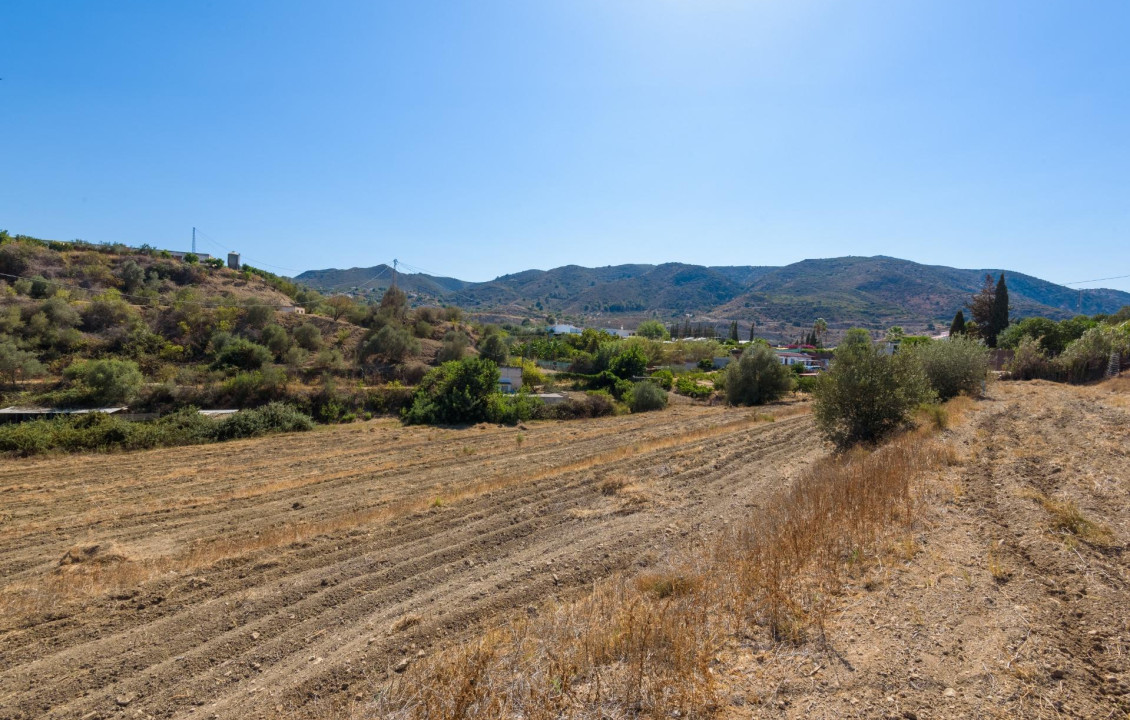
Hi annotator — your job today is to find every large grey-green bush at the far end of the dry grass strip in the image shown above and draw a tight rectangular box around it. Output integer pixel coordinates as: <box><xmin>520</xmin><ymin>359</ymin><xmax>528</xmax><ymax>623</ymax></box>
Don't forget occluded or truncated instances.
<box><xmin>812</xmin><ymin>332</ymin><xmax>933</xmax><ymax>450</ymax></box>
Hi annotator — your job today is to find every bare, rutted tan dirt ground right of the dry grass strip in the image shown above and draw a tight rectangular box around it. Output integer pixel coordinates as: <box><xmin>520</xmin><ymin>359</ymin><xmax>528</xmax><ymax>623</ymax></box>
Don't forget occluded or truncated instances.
<box><xmin>723</xmin><ymin>381</ymin><xmax>1130</xmax><ymax>720</ymax></box>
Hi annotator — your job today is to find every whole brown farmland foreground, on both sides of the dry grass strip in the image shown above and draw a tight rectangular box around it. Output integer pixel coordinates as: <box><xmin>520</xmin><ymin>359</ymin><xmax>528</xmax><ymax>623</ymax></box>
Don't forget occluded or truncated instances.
<box><xmin>0</xmin><ymin>379</ymin><xmax>1130</xmax><ymax>720</ymax></box>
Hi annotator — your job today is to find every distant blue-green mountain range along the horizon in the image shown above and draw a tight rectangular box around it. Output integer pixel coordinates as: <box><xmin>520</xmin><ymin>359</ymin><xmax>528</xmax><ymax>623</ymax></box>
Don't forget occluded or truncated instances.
<box><xmin>294</xmin><ymin>255</ymin><xmax>1130</xmax><ymax>336</ymax></box>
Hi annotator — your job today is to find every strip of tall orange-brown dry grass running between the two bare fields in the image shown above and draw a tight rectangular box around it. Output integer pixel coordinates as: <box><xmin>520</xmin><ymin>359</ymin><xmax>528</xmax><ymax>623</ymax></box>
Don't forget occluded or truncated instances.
<box><xmin>359</xmin><ymin>402</ymin><xmax>962</xmax><ymax>720</ymax></box>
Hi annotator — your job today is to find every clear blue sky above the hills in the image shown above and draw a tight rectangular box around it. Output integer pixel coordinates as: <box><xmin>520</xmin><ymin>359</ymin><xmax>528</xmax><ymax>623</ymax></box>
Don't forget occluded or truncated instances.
<box><xmin>0</xmin><ymin>0</ymin><xmax>1130</xmax><ymax>289</ymax></box>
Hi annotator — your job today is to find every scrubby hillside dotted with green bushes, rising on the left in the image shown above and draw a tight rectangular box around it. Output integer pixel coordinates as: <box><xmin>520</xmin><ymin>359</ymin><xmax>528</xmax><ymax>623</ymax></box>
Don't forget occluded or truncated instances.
<box><xmin>0</xmin><ymin>231</ymin><xmax>463</xmax><ymax>418</ymax></box>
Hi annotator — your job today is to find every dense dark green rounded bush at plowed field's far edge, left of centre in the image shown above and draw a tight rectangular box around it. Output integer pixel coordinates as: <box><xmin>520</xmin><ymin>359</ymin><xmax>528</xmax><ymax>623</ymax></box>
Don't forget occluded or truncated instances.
<box><xmin>402</xmin><ymin>357</ymin><xmax>499</xmax><ymax>425</ymax></box>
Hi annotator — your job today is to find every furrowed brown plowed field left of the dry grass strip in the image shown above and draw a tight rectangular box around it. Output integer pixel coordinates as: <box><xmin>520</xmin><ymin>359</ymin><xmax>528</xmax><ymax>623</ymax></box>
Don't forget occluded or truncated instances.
<box><xmin>0</xmin><ymin>406</ymin><xmax>824</xmax><ymax>719</ymax></box>
